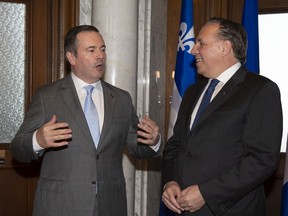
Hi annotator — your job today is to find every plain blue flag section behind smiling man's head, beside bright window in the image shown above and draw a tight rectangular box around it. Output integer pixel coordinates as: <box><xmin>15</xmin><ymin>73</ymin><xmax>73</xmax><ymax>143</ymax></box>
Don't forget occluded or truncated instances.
<box><xmin>242</xmin><ymin>0</ymin><xmax>260</xmax><ymax>74</ymax></box>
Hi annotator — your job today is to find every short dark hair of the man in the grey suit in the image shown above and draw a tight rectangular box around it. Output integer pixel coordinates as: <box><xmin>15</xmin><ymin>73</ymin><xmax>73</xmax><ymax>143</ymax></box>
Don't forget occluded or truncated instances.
<box><xmin>64</xmin><ymin>25</ymin><xmax>99</xmax><ymax>58</ymax></box>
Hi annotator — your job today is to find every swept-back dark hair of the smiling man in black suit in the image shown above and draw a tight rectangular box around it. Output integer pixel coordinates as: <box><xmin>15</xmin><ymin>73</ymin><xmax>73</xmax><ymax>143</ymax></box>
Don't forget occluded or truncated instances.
<box><xmin>207</xmin><ymin>17</ymin><xmax>248</xmax><ymax>63</ymax></box>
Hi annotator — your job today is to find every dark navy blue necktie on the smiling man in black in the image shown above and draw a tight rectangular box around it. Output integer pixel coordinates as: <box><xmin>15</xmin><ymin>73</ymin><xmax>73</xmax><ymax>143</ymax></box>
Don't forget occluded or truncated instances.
<box><xmin>192</xmin><ymin>79</ymin><xmax>219</xmax><ymax>128</ymax></box>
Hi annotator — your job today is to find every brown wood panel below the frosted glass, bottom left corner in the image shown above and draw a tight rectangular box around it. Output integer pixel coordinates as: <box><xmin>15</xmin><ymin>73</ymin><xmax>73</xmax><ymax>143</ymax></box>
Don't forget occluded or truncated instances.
<box><xmin>0</xmin><ymin>145</ymin><xmax>40</xmax><ymax>216</ymax></box>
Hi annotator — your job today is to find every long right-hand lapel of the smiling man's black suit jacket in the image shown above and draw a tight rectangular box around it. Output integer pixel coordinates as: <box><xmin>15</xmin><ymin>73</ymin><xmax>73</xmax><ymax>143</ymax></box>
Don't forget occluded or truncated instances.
<box><xmin>194</xmin><ymin>67</ymin><xmax>247</xmax><ymax>128</ymax></box>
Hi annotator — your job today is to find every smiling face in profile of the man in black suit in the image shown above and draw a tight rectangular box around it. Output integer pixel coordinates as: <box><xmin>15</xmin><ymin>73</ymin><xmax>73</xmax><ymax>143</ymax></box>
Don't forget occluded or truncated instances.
<box><xmin>191</xmin><ymin>23</ymin><xmax>232</xmax><ymax>78</ymax></box>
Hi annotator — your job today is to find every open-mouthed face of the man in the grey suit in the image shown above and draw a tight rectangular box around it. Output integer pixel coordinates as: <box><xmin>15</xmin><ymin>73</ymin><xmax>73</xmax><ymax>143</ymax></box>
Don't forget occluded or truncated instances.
<box><xmin>66</xmin><ymin>31</ymin><xmax>106</xmax><ymax>83</ymax></box>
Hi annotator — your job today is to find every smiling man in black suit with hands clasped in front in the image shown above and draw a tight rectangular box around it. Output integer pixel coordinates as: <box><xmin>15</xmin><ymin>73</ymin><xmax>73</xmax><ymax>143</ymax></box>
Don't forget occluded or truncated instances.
<box><xmin>162</xmin><ymin>18</ymin><xmax>283</xmax><ymax>216</ymax></box>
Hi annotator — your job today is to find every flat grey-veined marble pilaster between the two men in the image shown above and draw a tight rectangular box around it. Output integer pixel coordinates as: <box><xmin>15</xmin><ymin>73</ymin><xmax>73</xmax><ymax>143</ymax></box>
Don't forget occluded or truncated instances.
<box><xmin>134</xmin><ymin>0</ymin><xmax>167</xmax><ymax>216</ymax></box>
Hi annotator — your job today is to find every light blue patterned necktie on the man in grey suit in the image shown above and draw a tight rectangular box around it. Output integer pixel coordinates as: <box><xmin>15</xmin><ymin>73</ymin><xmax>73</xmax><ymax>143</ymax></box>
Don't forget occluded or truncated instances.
<box><xmin>84</xmin><ymin>85</ymin><xmax>100</xmax><ymax>148</ymax></box>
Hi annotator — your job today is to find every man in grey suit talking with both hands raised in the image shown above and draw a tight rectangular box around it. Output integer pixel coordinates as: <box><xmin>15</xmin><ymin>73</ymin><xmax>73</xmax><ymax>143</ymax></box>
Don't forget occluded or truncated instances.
<box><xmin>11</xmin><ymin>25</ymin><xmax>162</xmax><ymax>216</ymax></box>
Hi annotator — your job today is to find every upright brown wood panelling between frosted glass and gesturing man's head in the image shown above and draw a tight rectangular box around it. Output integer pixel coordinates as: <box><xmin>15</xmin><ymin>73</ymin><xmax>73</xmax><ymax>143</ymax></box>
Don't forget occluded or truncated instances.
<box><xmin>27</xmin><ymin>0</ymin><xmax>79</xmax><ymax>100</ymax></box>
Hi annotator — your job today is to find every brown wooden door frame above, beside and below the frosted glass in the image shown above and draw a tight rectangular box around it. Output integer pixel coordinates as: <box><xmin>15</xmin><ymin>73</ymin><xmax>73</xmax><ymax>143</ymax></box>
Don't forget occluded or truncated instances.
<box><xmin>0</xmin><ymin>0</ymin><xmax>79</xmax><ymax>216</ymax></box>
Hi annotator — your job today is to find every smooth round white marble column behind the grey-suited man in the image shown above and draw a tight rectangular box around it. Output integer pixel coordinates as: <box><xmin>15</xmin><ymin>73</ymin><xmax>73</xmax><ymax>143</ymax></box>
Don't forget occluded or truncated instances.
<box><xmin>83</xmin><ymin>0</ymin><xmax>138</xmax><ymax>216</ymax></box>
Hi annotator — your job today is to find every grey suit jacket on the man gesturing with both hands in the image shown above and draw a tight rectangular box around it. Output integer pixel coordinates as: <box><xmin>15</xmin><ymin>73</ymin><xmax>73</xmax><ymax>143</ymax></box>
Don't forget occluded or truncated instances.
<box><xmin>11</xmin><ymin>75</ymin><xmax>161</xmax><ymax>216</ymax></box>
